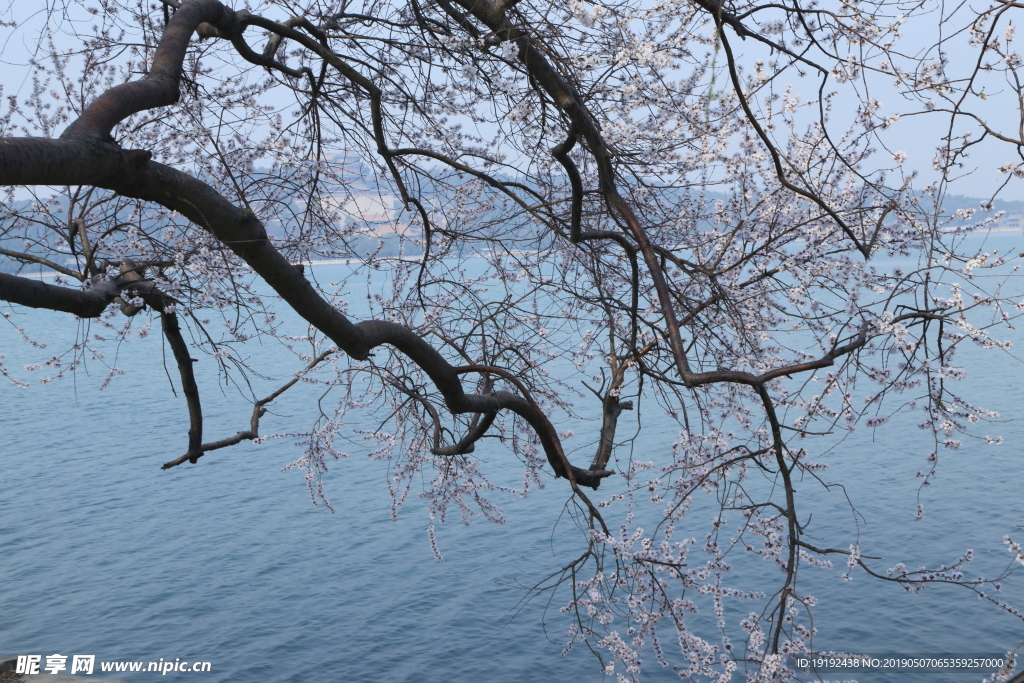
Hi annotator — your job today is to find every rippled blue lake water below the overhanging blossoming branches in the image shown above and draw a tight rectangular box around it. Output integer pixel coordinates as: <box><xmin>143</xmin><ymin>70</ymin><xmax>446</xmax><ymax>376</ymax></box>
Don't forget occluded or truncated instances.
<box><xmin>0</xmin><ymin>236</ymin><xmax>1024</xmax><ymax>683</ymax></box>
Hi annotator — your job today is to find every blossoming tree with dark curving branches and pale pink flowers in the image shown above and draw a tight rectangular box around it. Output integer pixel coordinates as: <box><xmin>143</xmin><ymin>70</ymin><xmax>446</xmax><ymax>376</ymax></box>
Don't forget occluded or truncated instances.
<box><xmin>0</xmin><ymin>0</ymin><xmax>1024</xmax><ymax>681</ymax></box>
